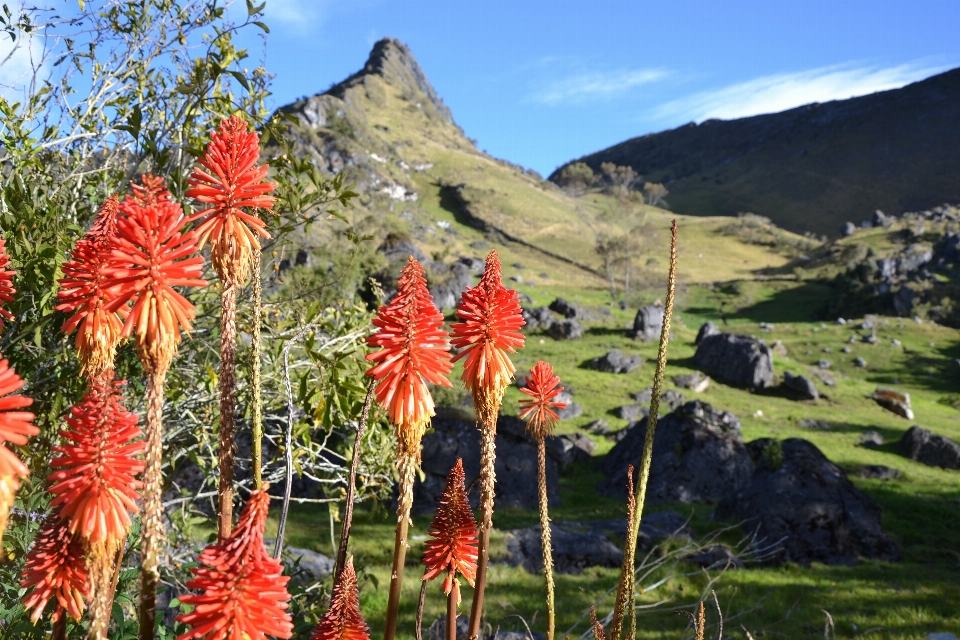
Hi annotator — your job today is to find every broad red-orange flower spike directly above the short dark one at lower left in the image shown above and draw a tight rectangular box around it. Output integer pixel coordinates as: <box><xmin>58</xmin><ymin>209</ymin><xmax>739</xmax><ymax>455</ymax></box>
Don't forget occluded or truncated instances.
<box><xmin>47</xmin><ymin>370</ymin><xmax>146</xmax><ymax>553</ymax></box>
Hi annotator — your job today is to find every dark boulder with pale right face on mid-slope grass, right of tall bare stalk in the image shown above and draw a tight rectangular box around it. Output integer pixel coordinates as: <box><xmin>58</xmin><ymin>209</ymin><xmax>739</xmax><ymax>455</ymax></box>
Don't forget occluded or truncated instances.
<box><xmin>693</xmin><ymin>328</ymin><xmax>774</xmax><ymax>389</ymax></box>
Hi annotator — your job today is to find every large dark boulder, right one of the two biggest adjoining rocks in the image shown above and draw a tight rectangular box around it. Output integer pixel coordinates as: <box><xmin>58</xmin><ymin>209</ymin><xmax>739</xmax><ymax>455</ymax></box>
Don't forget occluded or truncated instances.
<box><xmin>714</xmin><ymin>438</ymin><xmax>902</xmax><ymax>564</ymax></box>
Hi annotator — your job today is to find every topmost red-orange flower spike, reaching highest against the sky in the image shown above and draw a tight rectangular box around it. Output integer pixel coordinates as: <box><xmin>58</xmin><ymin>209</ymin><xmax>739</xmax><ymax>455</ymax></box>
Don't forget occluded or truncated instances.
<box><xmin>187</xmin><ymin>116</ymin><xmax>276</xmax><ymax>285</ymax></box>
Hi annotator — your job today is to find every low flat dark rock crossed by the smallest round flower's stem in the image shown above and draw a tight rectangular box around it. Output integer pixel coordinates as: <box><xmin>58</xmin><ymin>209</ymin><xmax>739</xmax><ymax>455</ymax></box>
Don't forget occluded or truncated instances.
<box><xmin>507</xmin><ymin>522</ymin><xmax>623</xmax><ymax>574</ymax></box>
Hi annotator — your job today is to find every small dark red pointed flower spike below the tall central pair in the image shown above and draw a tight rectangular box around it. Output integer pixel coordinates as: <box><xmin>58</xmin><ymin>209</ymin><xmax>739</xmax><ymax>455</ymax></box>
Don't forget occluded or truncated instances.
<box><xmin>423</xmin><ymin>458</ymin><xmax>478</xmax><ymax>605</ymax></box>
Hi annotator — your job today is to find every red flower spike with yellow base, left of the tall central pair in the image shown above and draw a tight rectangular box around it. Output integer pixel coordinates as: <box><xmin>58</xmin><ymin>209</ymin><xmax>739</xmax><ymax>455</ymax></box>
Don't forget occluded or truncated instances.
<box><xmin>367</xmin><ymin>256</ymin><xmax>453</xmax><ymax>459</ymax></box>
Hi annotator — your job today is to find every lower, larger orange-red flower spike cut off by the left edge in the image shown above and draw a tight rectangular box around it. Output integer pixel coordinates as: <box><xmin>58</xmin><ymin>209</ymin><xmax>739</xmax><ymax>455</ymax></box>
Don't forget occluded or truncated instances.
<box><xmin>0</xmin><ymin>360</ymin><xmax>40</xmax><ymax>539</ymax></box>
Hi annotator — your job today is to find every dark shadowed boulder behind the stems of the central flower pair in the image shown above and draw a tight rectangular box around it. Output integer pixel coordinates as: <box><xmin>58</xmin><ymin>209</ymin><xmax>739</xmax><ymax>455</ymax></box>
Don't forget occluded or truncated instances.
<box><xmin>413</xmin><ymin>407</ymin><xmax>560</xmax><ymax>514</ymax></box>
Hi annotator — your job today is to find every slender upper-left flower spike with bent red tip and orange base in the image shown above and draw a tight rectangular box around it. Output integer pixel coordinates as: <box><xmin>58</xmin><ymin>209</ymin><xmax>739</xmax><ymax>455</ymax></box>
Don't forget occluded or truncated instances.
<box><xmin>57</xmin><ymin>196</ymin><xmax>130</xmax><ymax>377</ymax></box>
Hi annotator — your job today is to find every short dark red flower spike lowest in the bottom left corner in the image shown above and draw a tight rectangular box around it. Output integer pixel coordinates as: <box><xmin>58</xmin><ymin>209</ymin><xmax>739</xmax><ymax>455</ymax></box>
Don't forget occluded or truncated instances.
<box><xmin>20</xmin><ymin>510</ymin><xmax>88</xmax><ymax>623</ymax></box>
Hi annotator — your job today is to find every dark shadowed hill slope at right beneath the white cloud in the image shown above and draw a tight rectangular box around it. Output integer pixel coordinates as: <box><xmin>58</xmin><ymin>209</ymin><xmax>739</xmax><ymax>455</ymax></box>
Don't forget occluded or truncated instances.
<box><xmin>551</xmin><ymin>69</ymin><xmax>960</xmax><ymax>235</ymax></box>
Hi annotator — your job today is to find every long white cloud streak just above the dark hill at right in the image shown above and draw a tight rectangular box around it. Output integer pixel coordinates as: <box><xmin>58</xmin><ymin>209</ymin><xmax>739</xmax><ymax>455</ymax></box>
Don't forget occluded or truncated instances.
<box><xmin>653</xmin><ymin>63</ymin><xmax>950</xmax><ymax>122</ymax></box>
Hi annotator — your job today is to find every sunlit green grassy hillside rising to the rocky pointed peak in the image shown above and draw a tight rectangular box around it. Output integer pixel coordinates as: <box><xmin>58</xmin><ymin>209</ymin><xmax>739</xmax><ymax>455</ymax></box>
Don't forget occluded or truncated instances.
<box><xmin>258</xmin><ymin>41</ymin><xmax>960</xmax><ymax>639</ymax></box>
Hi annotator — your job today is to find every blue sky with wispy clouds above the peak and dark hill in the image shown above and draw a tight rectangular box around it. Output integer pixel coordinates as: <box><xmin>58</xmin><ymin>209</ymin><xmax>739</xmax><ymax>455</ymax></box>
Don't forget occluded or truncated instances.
<box><xmin>241</xmin><ymin>0</ymin><xmax>960</xmax><ymax>175</ymax></box>
